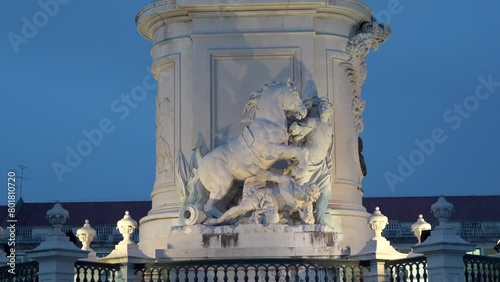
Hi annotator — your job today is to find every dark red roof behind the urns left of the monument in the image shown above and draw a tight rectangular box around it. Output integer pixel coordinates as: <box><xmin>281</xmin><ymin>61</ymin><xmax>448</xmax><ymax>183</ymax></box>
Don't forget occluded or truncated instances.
<box><xmin>0</xmin><ymin>201</ymin><xmax>151</xmax><ymax>227</ymax></box>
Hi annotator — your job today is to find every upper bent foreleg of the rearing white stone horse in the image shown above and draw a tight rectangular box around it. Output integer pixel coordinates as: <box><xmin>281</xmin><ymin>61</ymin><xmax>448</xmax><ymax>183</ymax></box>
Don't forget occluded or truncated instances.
<box><xmin>262</xmin><ymin>144</ymin><xmax>309</xmax><ymax>178</ymax></box>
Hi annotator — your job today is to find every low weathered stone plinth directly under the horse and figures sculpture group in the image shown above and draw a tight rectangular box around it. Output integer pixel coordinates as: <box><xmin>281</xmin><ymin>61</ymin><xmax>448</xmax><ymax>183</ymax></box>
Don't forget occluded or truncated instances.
<box><xmin>156</xmin><ymin>224</ymin><xmax>348</xmax><ymax>261</ymax></box>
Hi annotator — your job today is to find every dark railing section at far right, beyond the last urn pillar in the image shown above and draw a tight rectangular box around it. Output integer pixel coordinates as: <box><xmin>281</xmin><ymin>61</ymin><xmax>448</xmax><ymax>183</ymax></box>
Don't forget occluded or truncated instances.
<box><xmin>464</xmin><ymin>255</ymin><xmax>500</xmax><ymax>282</ymax></box>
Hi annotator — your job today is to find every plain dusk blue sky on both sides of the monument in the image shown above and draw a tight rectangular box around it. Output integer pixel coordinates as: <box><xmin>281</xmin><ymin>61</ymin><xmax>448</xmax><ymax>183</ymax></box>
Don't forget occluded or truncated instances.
<box><xmin>0</xmin><ymin>0</ymin><xmax>500</xmax><ymax>204</ymax></box>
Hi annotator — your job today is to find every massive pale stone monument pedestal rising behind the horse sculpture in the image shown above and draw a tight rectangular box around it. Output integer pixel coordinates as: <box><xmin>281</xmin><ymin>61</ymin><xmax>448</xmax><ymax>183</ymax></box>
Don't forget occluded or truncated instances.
<box><xmin>136</xmin><ymin>0</ymin><xmax>389</xmax><ymax>256</ymax></box>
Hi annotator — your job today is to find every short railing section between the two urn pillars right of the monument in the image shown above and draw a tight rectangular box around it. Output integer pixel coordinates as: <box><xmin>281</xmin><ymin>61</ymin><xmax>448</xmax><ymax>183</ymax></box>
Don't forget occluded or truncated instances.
<box><xmin>385</xmin><ymin>256</ymin><xmax>427</xmax><ymax>282</ymax></box>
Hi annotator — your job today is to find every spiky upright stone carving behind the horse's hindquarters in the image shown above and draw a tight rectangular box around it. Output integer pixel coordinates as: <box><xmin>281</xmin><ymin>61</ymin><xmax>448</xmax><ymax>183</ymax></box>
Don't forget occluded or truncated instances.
<box><xmin>176</xmin><ymin>148</ymin><xmax>209</xmax><ymax>209</ymax></box>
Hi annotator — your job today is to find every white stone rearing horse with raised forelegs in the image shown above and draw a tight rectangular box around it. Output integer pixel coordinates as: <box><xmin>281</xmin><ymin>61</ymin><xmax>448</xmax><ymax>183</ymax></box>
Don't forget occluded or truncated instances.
<box><xmin>182</xmin><ymin>81</ymin><xmax>308</xmax><ymax>217</ymax></box>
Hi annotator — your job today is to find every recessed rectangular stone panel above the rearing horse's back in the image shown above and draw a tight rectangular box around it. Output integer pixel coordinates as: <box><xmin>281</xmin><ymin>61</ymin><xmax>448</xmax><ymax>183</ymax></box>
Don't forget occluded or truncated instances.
<box><xmin>211</xmin><ymin>48</ymin><xmax>299</xmax><ymax>146</ymax></box>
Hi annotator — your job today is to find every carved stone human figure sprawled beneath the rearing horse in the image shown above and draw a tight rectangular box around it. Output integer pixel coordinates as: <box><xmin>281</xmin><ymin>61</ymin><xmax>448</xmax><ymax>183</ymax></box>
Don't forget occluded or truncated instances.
<box><xmin>205</xmin><ymin>176</ymin><xmax>320</xmax><ymax>225</ymax></box>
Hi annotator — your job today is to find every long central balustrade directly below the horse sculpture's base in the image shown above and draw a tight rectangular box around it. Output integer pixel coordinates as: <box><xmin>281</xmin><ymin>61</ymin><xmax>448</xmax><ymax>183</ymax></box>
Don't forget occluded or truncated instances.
<box><xmin>135</xmin><ymin>258</ymin><xmax>367</xmax><ymax>282</ymax></box>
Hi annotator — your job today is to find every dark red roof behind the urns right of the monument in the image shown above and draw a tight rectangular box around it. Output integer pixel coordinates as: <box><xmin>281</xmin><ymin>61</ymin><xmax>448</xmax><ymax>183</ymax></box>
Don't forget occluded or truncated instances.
<box><xmin>363</xmin><ymin>196</ymin><xmax>500</xmax><ymax>222</ymax></box>
